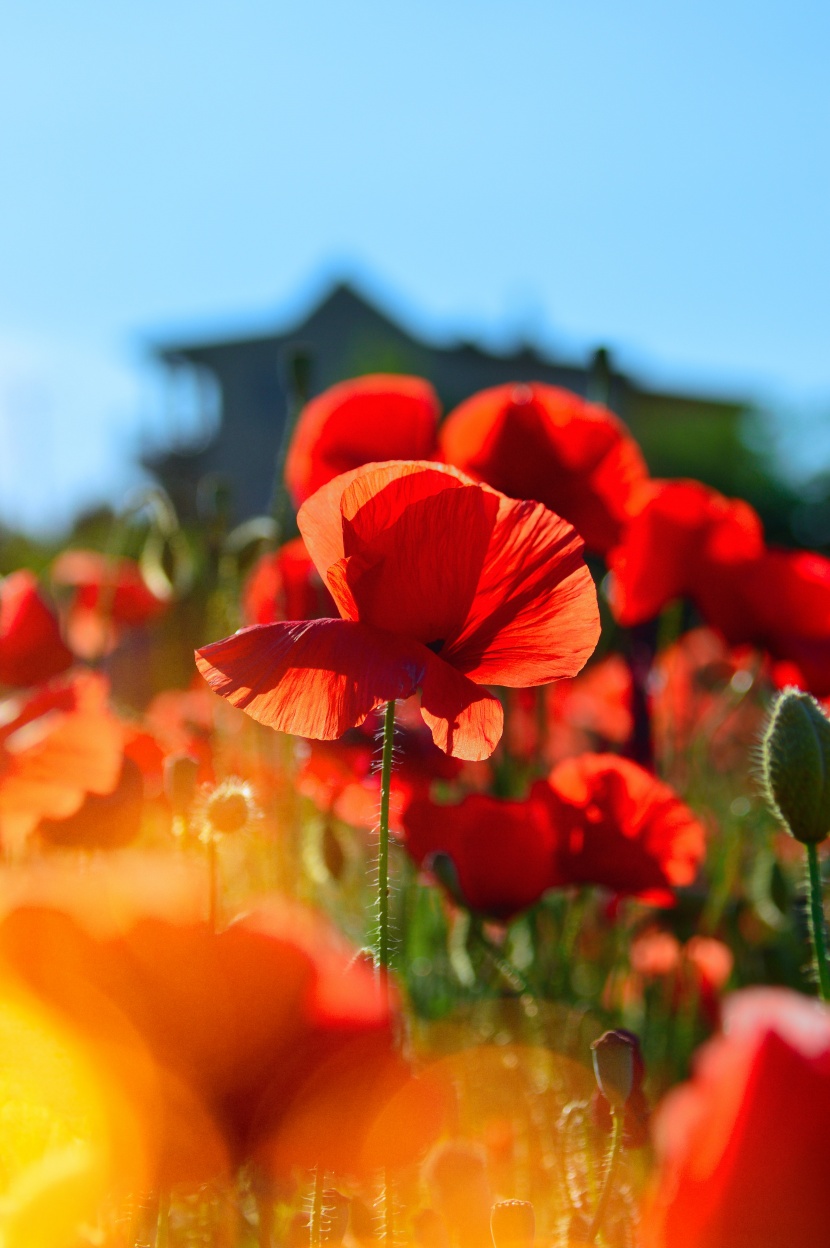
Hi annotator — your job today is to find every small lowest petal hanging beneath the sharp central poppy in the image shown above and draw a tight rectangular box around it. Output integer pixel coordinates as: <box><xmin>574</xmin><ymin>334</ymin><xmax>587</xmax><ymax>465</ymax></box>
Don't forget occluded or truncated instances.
<box><xmin>421</xmin><ymin>650</ymin><xmax>504</xmax><ymax>763</ymax></box>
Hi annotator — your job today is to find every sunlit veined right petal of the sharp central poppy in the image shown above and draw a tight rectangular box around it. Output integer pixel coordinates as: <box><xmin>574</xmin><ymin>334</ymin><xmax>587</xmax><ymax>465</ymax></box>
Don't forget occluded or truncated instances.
<box><xmin>442</xmin><ymin>497</ymin><xmax>599</xmax><ymax>688</ymax></box>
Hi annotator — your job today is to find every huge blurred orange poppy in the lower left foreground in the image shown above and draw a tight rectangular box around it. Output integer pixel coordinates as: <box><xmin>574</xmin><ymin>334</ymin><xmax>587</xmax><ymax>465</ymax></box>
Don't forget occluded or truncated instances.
<box><xmin>0</xmin><ymin>859</ymin><xmax>443</xmax><ymax>1183</ymax></box>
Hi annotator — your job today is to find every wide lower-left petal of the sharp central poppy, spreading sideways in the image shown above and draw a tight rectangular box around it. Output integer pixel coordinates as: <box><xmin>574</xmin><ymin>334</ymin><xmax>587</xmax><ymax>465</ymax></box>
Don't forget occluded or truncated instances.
<box><xmin>196</xmin><ymin>620</ymin><xmax>429</xmax><ymax>740</ymax></box>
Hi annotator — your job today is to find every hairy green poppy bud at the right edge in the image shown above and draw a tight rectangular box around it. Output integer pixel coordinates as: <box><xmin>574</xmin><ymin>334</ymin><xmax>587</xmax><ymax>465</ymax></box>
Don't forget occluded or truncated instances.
<box><xmin>761</xmin><ymin>689</ymin><xmax>830</xmax><ymax>845</ymax></box>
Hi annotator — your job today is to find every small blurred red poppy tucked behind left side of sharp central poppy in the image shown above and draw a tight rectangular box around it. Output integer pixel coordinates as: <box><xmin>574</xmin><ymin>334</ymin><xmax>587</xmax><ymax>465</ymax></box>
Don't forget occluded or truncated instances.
<box><xmin>242</xmin><ymin>538</ymin><xmax>337</xmax><ymax>624</ymax></box>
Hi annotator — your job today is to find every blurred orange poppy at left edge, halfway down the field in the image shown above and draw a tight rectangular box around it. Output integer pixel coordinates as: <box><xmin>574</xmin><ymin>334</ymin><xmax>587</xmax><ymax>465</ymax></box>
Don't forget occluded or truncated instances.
<box><xmin>0</xmin><ymin>673</ymin><xmax>124</xmax><ymax>852</ymax></box>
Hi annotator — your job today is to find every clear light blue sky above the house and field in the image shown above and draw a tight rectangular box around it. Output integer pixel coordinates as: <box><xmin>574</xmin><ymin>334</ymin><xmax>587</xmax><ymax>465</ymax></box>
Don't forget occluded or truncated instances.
<box><xmin>0</xmin><ymin>0</ymin><xmax>830</xmax><ymax>528</ymax></box>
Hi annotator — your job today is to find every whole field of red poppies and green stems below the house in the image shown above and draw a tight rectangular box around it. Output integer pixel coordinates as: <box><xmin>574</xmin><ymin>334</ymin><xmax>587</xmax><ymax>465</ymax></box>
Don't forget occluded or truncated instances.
<box><xmin>0</xmin><ymin>374</ymin><xmax>830</xmax><ymax>1248</ymax></box>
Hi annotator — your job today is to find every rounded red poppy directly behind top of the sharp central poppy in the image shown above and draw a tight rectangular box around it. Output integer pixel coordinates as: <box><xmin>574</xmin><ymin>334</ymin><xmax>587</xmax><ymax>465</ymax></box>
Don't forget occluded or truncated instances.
<box><xmin>286</xmin><ymin>373</ymin><xmax>441</xmax><ymax>507</ymax></box>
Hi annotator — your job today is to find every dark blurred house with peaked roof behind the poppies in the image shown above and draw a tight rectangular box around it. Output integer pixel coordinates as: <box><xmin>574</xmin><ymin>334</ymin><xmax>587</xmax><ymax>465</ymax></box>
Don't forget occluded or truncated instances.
<box><xmin>144</xmin><ymin>285</ymin><xmax>753</xmax><ymax>520</ymax></box>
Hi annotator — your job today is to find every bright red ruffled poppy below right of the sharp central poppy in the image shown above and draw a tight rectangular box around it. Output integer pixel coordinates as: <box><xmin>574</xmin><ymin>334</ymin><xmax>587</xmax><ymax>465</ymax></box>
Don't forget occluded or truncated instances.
<box><xmin>533</xmin><ymin>754</ymin><xmax>705</xmax><ymax>905</ymax></box>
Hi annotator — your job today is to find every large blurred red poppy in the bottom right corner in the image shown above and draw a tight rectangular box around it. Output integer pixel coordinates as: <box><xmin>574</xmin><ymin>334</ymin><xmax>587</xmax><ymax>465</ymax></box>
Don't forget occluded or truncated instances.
<box><xmin>643</xmin><ymin>988</ymin><xmax>830</xmax><ymax>1248</ymax></box>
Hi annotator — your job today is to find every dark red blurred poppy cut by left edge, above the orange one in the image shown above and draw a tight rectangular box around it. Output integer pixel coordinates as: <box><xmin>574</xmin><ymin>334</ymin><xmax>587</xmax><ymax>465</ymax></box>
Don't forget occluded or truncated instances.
<box><xmin>0</xmin><ymin>569</ymin><xmax>72</xmax><ymax>689</ymax></box>
